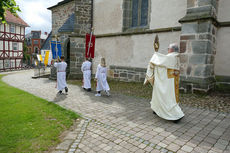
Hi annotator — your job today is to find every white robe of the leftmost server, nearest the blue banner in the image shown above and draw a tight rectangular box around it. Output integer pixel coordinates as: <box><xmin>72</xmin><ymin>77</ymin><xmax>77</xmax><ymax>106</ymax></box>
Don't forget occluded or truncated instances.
<box><xmin>54</xmin><ymin>62</ymin><xmax>67</xmax><ymax>91</ymax></box>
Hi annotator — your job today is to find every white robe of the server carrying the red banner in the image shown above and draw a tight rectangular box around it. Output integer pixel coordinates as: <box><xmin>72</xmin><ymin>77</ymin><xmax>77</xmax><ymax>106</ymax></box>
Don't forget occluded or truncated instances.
<box><xmin>81</xmin><ymin>61</ymin><xmax>92</xmax><ymax>89</ymax></box>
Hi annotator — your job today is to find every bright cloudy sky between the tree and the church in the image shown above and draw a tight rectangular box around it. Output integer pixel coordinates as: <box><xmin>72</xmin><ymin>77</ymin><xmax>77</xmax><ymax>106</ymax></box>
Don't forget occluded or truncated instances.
<box><xmin>16</xmin><ymin>0</ymin><xmax>63</xmax><ymax>34</ymax></box>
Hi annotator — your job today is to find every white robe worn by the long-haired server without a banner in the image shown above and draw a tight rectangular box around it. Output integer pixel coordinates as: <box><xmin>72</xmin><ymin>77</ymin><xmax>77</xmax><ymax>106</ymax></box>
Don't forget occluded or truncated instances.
<box><xmin>95</xmin><ymin>64</ymin><xmax>110</xmax><ymax>91</ymax></box>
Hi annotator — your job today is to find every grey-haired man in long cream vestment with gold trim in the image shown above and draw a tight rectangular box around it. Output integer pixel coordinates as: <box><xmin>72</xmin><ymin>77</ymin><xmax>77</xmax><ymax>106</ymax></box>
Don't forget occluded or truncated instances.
<box><xmin>144</xmin><ymin>44</ymin><xmax>184</xmax><ymax>123</ymax></box>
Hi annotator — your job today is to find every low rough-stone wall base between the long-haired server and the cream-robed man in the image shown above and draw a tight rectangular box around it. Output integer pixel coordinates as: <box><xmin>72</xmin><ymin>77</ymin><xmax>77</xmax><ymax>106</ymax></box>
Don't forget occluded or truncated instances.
<box><xmin>108</xmin><ymin>65</ymin><xmax>146</xmax><ymax>82</ymax></box>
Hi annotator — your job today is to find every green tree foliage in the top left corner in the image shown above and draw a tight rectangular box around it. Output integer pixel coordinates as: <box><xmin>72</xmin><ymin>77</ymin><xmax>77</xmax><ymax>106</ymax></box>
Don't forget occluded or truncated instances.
<box><xmin>0</xmin><ymin>0</ymin><xmax>21</xmax><ymax>23</ymax></box>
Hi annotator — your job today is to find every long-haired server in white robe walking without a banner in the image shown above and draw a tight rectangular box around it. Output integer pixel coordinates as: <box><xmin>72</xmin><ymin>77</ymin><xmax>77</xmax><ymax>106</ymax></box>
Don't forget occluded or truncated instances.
<box><xmin>95</xmin><ymin>58</ymin><xmax>110</xmax><ymax>96</ymax></box>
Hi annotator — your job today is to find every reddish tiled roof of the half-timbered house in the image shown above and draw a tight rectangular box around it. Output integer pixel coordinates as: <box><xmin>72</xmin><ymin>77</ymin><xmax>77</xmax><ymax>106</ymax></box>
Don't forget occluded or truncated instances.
<box><xmin>6</xmin><ymin>10</ymin><xmax>29</xmax><ymax>27</ymax></box>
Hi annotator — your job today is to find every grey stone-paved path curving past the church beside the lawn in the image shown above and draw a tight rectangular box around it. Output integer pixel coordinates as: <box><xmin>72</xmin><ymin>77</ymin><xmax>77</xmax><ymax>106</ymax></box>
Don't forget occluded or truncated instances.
<box><xmin>3</xmin><ymin>70</ymin><xmax>230</xmax><ymax>153</ymax></box>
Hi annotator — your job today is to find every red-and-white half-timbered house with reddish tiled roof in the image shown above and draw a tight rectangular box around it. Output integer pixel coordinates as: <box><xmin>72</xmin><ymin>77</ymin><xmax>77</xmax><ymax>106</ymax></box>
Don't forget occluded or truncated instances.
<box><xmin>0</xmin><ymin>11</ymin><xmax>28</xmax><ymax>71</ymax></box>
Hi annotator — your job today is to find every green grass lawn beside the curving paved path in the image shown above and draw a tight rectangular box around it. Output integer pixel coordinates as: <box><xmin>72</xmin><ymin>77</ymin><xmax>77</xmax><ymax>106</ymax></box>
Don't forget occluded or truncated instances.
<box><xmin>0</xmin><ymin>75</ymin><xmax>79</xmax><ymax>153</ymax></box>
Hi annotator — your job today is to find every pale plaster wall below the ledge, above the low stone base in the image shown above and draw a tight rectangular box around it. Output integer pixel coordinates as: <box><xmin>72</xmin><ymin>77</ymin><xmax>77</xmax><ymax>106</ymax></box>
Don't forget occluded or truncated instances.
<box><xmin>93</xmin><ymin>32</ymin><xmax>180</xmax><ymax>73</ymax></box>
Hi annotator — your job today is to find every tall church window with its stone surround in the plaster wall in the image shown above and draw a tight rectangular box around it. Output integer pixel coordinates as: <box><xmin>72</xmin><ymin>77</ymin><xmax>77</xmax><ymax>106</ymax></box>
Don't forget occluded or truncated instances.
<box><xmin>123</xmin><ymin>0</ymin><xmax>150</xmax><ymax>30</ymax></box>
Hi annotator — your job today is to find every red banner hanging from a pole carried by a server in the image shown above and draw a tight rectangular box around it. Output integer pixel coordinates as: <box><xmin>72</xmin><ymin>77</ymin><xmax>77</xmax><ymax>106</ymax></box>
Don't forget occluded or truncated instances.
<box><xmin>85</xmin><ymin>33</ymin><xmax>95</xmax><ymax>58</ymax></box>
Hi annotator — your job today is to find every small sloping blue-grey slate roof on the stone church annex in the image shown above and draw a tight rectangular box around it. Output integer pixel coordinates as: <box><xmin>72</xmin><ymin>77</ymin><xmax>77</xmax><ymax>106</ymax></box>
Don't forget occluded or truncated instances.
<box><xmin>58</xmin><ymin>13</ymin><xmax>75</xmax><ymax>32</ymax></box>
